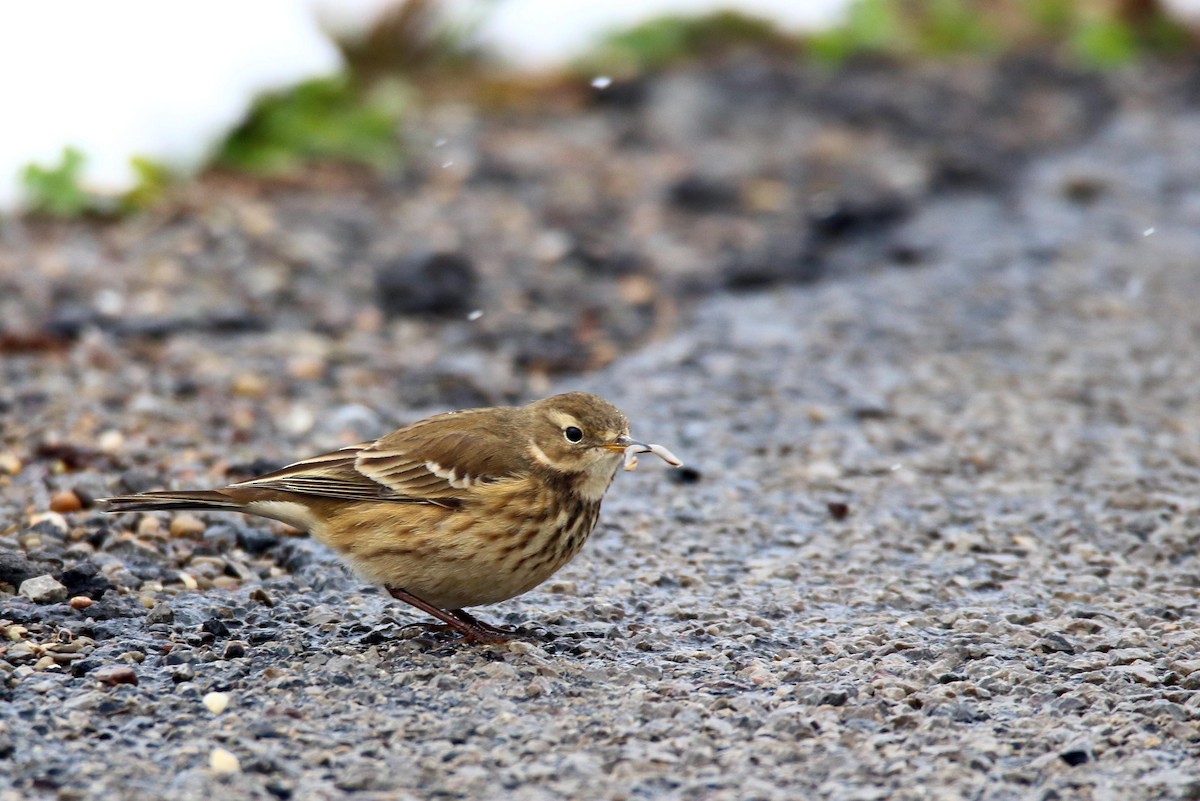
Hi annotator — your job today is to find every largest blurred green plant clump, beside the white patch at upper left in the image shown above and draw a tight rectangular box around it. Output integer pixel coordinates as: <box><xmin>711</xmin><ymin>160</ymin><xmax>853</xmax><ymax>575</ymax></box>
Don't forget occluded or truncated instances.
<box><xmin>217</xmin><ymin>76</ymin><xmax>408</xmax><ymax>174</ymax></box>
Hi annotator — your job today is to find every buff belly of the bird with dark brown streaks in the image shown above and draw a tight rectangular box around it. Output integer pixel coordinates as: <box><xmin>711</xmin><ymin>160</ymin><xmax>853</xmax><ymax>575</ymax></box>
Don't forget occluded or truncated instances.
<box><xmin>313</xmin><ymin>491</ymin><xmax>600</xmax><ymax>609</ymax></box>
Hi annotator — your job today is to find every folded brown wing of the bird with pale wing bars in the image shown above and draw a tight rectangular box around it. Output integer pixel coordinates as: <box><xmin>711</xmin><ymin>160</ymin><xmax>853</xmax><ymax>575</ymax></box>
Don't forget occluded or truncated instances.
<box><xmin>230</xmin><ymin>412</ymin><xmax>528</xmax><ymax>506</ymax></box>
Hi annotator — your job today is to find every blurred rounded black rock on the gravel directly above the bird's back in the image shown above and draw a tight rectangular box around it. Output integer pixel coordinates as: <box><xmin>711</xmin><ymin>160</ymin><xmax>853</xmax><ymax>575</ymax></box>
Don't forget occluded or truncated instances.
<box><xmin>376</xmin><ymin>253</ymin><xmax>479</xmax><ymax>317</ymax></box>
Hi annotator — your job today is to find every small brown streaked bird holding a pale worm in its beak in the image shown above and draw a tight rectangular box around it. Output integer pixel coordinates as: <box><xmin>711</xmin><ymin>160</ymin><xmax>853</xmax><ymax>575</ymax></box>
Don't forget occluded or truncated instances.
<box><xmin>102</xmin><ymin>392</ymin><xmax>682</xmax><ymax>643</ymax></box>
